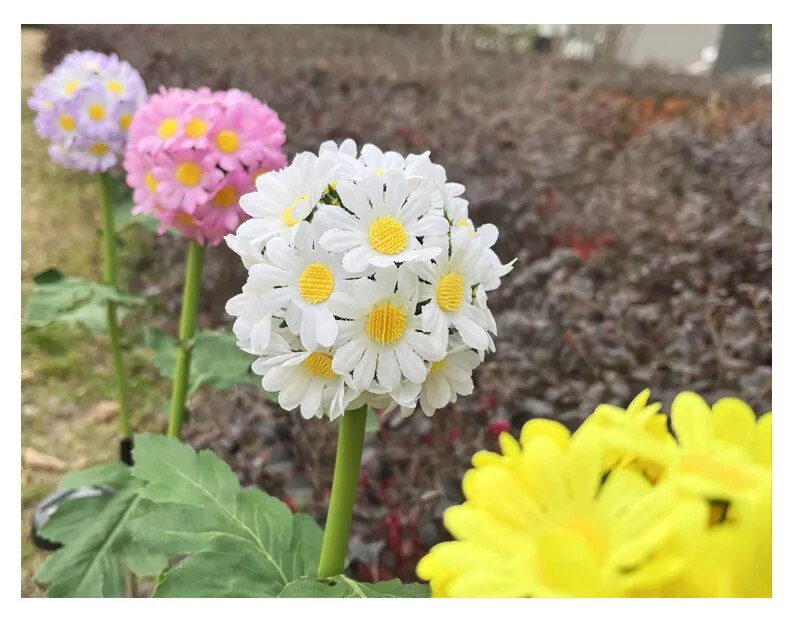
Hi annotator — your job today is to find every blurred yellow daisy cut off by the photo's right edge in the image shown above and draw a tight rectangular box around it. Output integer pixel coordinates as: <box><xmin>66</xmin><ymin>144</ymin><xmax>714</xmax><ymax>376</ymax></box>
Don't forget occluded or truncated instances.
<box><xmin>652</xmin><ymin>392</ymin><xmax>772</xmax><ymax>597</ymax></box>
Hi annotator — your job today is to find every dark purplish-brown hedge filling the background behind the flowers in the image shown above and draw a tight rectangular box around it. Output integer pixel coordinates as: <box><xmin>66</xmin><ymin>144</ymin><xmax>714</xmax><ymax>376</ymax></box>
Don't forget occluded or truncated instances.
<box><xmin>45</xmin><ymin>26</ymin><xmax>771</xmax><ymax>579</ymax></box>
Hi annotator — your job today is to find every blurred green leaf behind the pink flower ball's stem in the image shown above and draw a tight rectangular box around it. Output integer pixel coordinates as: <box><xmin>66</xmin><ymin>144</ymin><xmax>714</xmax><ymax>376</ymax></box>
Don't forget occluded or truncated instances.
<box><xmin>146</xmin><ymin>327</ymin><xmax>260</xmax><ymax>396</ymax></box>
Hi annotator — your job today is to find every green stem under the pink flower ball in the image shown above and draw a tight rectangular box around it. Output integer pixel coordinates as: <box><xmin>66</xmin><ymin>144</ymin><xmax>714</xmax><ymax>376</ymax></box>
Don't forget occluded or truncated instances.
<box><xmin>167</xmin><ymin>241</ymin><xmax>204</xmax><ymax>438</ymax></box>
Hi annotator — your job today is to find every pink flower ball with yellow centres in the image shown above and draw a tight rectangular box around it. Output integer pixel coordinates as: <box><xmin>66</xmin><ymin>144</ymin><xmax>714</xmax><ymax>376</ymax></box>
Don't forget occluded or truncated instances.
<box><xmin>123</xmin><ymin>88</ymin><xmax>287</xmax><ymax>245</ymax></box>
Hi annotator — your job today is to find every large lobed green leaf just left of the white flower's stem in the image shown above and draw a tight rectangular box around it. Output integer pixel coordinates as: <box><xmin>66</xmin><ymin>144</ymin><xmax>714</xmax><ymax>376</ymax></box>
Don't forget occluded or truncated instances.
<box><xmin>131</xmin><ymin>435</ymin><xmax>322</xmax><ymax>597</ymax></box>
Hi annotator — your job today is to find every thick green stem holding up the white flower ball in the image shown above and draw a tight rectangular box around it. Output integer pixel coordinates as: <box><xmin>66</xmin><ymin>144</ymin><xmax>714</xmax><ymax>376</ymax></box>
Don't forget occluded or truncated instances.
<box><xmin>318</xmin><ymin>406</ymin><xmax>367</xmax><ymax>578</ymax></box>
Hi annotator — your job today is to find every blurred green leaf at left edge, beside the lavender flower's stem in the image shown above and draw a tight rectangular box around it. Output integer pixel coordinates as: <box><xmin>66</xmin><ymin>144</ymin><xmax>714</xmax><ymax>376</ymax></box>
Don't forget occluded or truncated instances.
<box><xmin>23</xmin><ymin>269</ymin><xmax>145</xmax><ymax>333</ymax></box>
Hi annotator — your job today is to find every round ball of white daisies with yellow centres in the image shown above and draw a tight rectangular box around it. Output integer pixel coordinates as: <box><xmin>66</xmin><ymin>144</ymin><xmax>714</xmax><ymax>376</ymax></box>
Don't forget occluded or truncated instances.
<box><xmin>225</xmin><ymin>140</ymin><xmax>514</xmax><ymax>419</ymax></box>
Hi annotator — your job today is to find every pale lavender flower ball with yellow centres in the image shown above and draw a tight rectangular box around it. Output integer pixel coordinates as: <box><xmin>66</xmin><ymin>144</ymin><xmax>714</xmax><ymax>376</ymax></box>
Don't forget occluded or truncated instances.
<box><xmin>27</xmin><ymin>51</ymin><xmax>147</xmax><ymax>174</ymax></box>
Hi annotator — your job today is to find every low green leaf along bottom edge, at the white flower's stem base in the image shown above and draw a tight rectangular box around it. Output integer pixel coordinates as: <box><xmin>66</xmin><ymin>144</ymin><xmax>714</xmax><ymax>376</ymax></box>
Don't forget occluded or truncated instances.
<box><xmin>279</xmin><ymin>576</ymin><xmax>430</xmax><ymax>598</ymax></box>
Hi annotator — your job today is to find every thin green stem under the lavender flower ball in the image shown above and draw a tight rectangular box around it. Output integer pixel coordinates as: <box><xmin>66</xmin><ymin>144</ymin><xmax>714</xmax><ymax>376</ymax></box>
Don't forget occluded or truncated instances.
<box><xmin>99</xmin><ymin>172</ymin><xmax>132</xmax><ymax>438</ymax></box>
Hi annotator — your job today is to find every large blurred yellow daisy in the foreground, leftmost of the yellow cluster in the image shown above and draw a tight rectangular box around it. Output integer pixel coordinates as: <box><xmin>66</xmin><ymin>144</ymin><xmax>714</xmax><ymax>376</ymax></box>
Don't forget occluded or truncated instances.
<box><xmin>417</xmin><ymin>420</ymin><xmax>705</xmax><ymax>597</ymax></box>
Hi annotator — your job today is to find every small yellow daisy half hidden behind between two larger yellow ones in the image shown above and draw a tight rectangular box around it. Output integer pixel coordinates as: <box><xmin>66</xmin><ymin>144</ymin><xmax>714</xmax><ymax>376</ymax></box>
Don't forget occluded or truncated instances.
<box><xmin>576</xmin><ymin>389</ymin><xmax>674</xmax><ymax>481</ymax></box>
